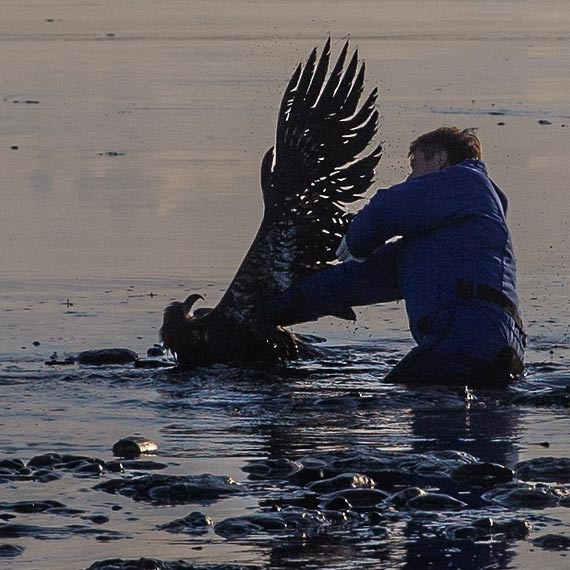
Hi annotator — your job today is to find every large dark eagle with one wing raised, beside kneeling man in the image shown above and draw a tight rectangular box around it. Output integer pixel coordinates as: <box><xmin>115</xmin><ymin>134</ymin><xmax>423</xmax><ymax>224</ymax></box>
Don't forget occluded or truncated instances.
<box><xmin>160</xmin><ymin>38</ymin><xmax>381</xmax><ymax>367</ymax></box>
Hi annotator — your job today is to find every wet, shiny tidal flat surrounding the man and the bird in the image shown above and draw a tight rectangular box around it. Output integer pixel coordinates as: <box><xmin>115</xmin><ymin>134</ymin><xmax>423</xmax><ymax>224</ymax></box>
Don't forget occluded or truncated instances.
<box><xmin>0</xmin><ymin>0</ymin><xmax>570</xmax><ymax>569</ymax></box>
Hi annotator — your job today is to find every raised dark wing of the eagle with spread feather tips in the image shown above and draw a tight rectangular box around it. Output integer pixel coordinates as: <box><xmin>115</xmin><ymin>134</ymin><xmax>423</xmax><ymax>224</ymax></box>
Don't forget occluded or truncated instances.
<box><xmin>217</xmin><ymin>38</ymin><xmax>381</xmax><ymax>320</ymax></box>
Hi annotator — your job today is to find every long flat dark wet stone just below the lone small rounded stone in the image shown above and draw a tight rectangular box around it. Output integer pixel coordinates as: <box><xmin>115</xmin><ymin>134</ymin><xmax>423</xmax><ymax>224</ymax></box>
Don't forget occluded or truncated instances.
<box><xmin>95</xmin><ymin>473</ymin><xmax>243</xmax><ymax>504</ymax></box>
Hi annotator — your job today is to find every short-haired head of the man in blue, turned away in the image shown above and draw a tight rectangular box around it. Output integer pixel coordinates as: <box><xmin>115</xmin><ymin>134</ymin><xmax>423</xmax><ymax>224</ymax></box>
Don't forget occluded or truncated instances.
<box><xmin>408</xmin><ymin>127</ymin><xmax>483</xmax><ymax>178</ymax></box>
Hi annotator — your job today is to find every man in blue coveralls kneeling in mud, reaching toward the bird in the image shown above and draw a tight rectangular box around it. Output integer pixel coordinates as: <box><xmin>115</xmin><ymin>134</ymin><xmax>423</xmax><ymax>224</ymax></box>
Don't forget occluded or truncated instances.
<box><xmin>262</xmin><ymin>127</ymin><xmax>526</xmax><ymax>388</ymax></box>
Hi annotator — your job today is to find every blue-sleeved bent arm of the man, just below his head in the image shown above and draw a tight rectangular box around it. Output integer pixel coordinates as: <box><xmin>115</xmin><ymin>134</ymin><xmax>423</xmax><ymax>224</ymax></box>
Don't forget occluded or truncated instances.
<box><xmin>345</xmin><ymin>167</ymin><xmax>486</xmax><ymax>257</ymax></box>
